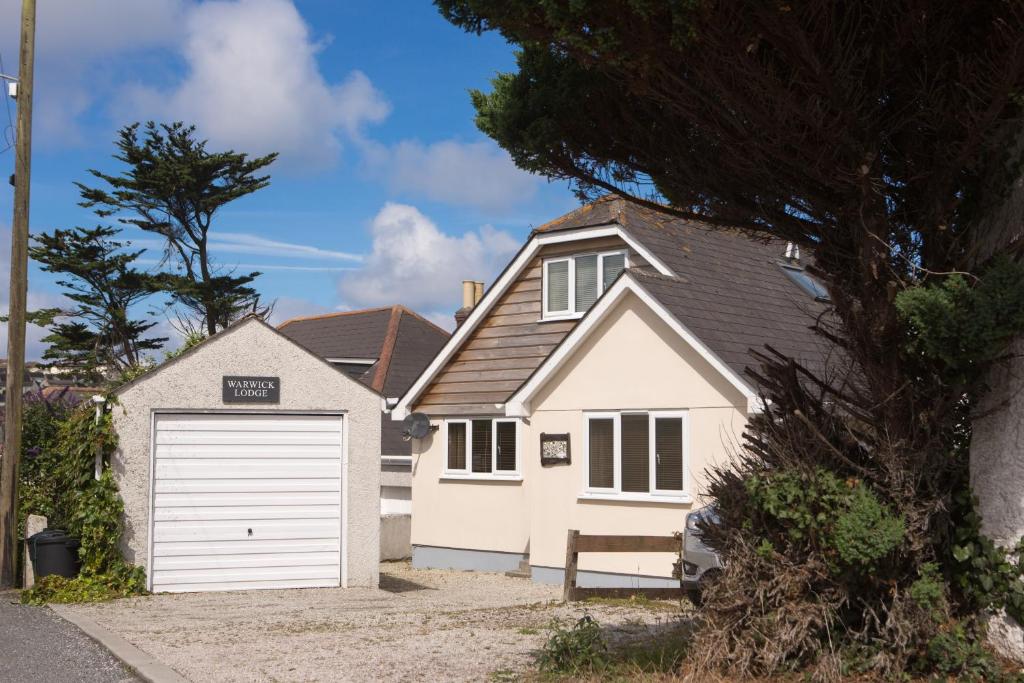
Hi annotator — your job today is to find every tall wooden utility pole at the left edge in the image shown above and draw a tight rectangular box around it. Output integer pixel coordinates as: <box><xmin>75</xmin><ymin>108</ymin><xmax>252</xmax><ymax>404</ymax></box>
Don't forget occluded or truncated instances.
<box><xmin>0</xmin><ymin>0</ymin><xmax>36</xmax><ymax>588</ymax></box>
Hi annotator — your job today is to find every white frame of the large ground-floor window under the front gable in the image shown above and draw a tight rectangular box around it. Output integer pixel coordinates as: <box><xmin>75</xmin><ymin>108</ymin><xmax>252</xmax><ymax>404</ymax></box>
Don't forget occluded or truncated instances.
<box><xmin>581</xmin><ymin>410</ymin><xmax>693</xmax><ymax>504</ymax></box>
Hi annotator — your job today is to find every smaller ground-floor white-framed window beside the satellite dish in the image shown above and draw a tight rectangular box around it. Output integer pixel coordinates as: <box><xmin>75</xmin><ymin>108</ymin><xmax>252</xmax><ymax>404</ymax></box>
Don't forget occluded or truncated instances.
<box><xmin>444</xmin><ymin>418</ymin><xmax>521</xmax><ymax>477</ymax></box>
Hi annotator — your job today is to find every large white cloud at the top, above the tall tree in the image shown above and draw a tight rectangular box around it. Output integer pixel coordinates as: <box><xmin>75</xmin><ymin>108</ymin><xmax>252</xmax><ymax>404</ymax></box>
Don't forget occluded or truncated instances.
<box><xmin>122</xmin><ymin>0</ymin><xmax>390</xmax><ymax>170</ymax></box>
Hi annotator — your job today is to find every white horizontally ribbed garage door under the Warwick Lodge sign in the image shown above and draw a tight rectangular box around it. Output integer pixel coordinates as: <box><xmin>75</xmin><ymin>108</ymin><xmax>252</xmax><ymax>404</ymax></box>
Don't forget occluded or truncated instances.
<box><xmin>152</xmin><ymin>415</ymin><xmax>342</xmax><ymax>592</ymax></box>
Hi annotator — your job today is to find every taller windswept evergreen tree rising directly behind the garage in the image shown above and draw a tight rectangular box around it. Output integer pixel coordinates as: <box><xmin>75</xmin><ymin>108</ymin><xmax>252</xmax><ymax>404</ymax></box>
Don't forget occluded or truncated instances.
<box><xmin>77</xmin><ymin>121</ymin><xmax>276</xmax><ymax>335</ymax></box>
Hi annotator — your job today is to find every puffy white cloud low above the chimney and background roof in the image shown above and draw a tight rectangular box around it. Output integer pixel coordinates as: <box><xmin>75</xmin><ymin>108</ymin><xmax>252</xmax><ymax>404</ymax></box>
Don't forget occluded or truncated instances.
<box><xmin>338</xmin><ymin>204</ymin><xmax>519</xmax><ymax>327</ymax></box>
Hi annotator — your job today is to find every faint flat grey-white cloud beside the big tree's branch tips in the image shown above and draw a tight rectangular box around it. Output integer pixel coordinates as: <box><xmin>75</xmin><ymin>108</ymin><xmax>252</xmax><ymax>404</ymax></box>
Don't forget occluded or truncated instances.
<box><xmin>364</xmin><ymin>140</ymin><xmax>541</xmax><ymax>210</ymax></box>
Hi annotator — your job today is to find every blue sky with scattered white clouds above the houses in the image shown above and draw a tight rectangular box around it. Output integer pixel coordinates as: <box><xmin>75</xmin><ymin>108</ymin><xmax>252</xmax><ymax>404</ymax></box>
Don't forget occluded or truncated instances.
<box><xmin>0</xmin><ymin>0</ymin><xmax>577</xmax><ymax>356</ymax></box>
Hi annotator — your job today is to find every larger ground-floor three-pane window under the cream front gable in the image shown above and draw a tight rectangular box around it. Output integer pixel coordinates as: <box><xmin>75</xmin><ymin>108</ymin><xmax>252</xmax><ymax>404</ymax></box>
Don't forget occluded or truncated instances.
<box><xmin>584</xmin><ymin>411</ymin><xmax>688</xmax><ymax>498</ymax></box>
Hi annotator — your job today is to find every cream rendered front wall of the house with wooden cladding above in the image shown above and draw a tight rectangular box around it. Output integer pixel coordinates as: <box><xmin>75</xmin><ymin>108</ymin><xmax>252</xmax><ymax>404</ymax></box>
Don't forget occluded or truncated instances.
<box><xmin>413</xmin><ymin>295</ymin><xmax>746</xmax><ymax>577</ymax></box>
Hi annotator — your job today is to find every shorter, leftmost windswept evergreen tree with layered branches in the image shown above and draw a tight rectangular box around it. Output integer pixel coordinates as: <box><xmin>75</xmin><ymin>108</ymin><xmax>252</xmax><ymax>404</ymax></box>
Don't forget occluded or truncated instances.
<box><xmin>29</xmin><ymin>226</ymin><xmax>167</xmax><ymax>381</ymax></box>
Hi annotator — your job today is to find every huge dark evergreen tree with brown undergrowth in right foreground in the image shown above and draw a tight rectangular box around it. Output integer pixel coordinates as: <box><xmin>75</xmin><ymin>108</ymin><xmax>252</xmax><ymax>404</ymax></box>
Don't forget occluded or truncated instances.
<box><xmin>435</xmin><ymin>0</ymin><xmax>1024</xmax><ymax>678</ymax></box>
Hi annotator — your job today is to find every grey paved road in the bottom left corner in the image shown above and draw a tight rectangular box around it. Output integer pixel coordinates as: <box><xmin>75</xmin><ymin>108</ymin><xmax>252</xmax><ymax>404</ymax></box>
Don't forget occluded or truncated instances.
<box><xmin>0</xmin><ymin>592</ymin><xmax>138</xmax><ymax>683</ymax></box>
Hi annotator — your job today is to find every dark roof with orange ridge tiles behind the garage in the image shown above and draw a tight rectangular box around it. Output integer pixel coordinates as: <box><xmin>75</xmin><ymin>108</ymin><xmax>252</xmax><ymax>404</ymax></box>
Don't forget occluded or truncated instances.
<box><xmin>279</xmin><ymin>305</ymin><xmax>450</xmax><ymax>456</ymax></box>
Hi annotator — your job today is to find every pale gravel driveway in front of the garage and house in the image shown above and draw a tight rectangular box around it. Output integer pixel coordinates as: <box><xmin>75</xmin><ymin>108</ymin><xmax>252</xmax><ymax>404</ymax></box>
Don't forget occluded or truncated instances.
<box><xmin>61</xmin><ymin>563</ymin><xmax>678</xmax><ymax>682</ymax></box>
